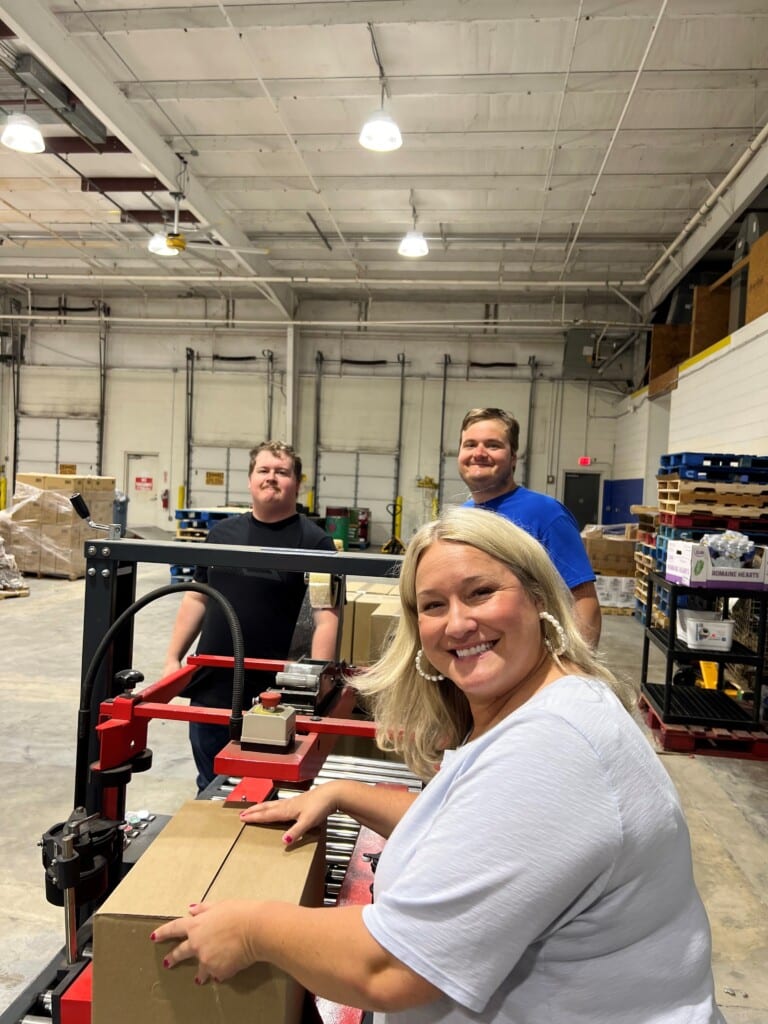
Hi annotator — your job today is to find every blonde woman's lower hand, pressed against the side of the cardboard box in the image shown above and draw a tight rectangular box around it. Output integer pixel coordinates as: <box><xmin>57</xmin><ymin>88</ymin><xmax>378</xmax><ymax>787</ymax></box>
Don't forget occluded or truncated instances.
<box><xmin>152</xmin><ymin>900</ymin><xmax>258</xmax><ymax>985</ymax></box>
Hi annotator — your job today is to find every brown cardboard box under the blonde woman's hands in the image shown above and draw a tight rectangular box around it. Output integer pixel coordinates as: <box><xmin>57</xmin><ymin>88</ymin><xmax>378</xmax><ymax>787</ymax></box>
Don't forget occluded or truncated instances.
<box><xmin>92</xmin><ymin>801</ymin><xmax>326</xmax><ymax>1024</ymax></box>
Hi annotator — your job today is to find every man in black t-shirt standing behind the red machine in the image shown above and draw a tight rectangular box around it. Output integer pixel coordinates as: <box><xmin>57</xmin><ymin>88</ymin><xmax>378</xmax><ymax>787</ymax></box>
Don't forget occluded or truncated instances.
<box><xmin>165</xmin><ymin>441</ymin><xmax>339</xmax><ymax>790</ymax></box>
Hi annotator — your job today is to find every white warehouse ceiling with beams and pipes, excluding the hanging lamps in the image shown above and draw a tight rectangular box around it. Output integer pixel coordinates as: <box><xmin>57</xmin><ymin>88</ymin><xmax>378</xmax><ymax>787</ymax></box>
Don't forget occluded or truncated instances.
<box><xmin>0</xmin><ymin>0</ymin><xmax>768</xmax><ymax>331</ymax></box>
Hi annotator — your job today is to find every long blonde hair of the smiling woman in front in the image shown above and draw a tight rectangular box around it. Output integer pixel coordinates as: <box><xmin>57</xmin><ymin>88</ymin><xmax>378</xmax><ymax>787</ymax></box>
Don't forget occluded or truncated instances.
<box><xmin>351</xmin><ymin>507</ymin><xmax>636</xmax><ymax>779</ymax></box>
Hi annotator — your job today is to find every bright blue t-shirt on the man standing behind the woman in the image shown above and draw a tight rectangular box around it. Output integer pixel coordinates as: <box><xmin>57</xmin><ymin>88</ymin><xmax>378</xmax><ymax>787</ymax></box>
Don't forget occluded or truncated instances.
<box><xmin>465</xmin><ymin>485</ymin><xmax>595</xmax><ymax>590</ymax></box>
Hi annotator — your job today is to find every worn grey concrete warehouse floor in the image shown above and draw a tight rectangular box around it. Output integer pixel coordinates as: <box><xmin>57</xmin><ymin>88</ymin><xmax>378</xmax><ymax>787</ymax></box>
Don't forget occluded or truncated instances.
<box><xmin>0</xmin><ymin>534</ymin><xmax>768</xmax><ymax>1024</ymax></box>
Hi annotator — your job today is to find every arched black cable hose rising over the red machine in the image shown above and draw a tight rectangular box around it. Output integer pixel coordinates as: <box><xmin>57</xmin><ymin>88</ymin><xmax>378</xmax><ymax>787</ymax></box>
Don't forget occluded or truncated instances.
<box><xmin>75</xmin><ymin>581</ymin><xmax>245</xmax><ymax>807</ymax></box>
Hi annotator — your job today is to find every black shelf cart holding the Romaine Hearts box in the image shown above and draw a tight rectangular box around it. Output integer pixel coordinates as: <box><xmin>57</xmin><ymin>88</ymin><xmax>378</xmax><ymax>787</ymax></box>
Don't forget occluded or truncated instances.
<box><xmin>640</xmin><ymin>572</ymin><xmax>768</xmax><ymax>730</ymax></box>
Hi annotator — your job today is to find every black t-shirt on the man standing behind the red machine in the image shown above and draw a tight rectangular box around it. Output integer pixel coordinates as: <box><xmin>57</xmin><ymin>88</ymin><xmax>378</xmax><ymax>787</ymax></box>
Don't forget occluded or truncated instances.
<box><xmin>184</xmin><ymin>512</ymin><xmax>336</xmax><ymax>709</ymax></box>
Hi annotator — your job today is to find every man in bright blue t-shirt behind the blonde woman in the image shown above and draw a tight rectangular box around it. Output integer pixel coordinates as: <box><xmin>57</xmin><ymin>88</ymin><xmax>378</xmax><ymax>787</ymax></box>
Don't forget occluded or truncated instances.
<box><xmin>459</xmin><ymin>409</ymin><xmax>602</xmax><ymax>647</ymax></box>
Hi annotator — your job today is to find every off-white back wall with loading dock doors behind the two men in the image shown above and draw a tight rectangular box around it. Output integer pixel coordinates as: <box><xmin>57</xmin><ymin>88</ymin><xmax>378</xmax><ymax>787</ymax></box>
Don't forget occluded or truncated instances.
<box><xmin>0</xmin><ymin>298</ymin><xmax>643</xmax><ymax>543</ymax></box>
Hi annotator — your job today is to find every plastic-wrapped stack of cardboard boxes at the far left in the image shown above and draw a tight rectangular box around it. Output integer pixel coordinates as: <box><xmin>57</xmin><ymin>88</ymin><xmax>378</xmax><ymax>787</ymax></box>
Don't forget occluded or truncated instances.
<box><xmin>4</xmin><ymin>473</ymin><xmax>115</xmax><ymax>580</ymax></box>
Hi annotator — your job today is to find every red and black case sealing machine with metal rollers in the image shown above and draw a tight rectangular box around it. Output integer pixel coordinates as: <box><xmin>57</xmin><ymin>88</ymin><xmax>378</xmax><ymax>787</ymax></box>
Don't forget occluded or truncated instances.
<box><xmin>0</xmin><ymin>532</ymin><xmax>409</xmax><ymax>1024</ymax></box>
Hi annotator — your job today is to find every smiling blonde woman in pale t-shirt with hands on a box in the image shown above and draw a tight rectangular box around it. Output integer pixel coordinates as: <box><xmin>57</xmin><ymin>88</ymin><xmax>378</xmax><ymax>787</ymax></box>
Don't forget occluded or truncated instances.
<box><xmin>154</xmin><ymin>509</ymin><xmax>723</xmax><ymax>1024</ymax></box>
